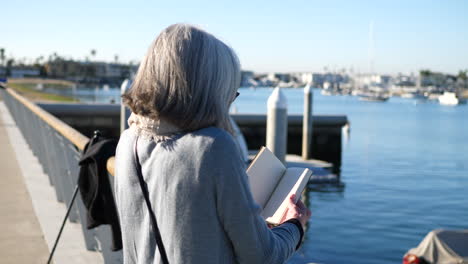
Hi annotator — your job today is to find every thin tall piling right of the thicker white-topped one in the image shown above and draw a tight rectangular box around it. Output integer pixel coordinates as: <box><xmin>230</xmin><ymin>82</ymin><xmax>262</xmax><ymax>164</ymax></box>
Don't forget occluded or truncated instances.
<box><xmin>302</xmin><ymin>84</ymin><xmax>314</xmax><ymax>160</ymax></box>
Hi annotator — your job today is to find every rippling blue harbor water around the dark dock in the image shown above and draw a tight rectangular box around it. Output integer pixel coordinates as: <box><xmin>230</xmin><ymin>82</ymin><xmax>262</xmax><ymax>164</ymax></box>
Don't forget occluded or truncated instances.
<box><xmin>48</xmin><ymin>86</ymin><xmax>468</xmax><ymax>264</ymax></box>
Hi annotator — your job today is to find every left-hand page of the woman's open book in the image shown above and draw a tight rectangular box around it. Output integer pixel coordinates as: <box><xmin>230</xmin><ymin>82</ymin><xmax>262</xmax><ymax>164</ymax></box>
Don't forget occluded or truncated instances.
<box><xmin>247</xmin><ymin>148</ymin><xmax>286</xmax><ymax>209</ymax></box>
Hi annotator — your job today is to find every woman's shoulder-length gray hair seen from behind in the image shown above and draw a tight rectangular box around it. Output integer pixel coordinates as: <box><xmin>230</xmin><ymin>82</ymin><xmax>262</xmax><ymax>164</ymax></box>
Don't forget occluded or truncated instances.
<box><xmin>122</xmin><ymin>24</ymin><xmax>240</xmax><ymax>133</ymax></box>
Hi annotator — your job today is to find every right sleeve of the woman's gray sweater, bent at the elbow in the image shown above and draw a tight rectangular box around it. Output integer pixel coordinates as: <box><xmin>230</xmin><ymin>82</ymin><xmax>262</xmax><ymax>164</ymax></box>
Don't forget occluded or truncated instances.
<box><xmin>210</xmin><ymin>134</ymin><xmax>301</xmax><ymax>263</ymax></box>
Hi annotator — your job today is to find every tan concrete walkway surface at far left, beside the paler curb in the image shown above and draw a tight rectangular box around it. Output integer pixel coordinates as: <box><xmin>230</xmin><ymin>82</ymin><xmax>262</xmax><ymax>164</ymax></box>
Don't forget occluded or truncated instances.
<box><xmin>0</xmin><ymin>102</ymin><xmax>49</xmax><ymax>263</ymax></box>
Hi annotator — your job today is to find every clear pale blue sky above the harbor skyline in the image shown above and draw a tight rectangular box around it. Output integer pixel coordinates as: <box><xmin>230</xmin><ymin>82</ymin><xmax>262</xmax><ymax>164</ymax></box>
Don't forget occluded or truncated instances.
<box><xmin>0</xmin><ymin>0</ymin><xmax>468</xmax><ymax>73</ymax></box>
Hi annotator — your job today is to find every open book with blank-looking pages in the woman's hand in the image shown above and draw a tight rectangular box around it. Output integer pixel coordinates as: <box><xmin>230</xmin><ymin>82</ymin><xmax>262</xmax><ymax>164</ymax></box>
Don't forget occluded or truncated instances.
<box><xmin>247</xmin><ymin>147</ymin><xmax>312</xmax><ymax>225</ymax></box>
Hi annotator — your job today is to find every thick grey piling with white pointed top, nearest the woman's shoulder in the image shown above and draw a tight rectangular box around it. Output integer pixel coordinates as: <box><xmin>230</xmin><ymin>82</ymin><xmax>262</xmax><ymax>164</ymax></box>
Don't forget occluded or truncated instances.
<box><xmin>266</xmin><ymin>87</ymin><xmax>288</xmax><ymax>163</ymax></box>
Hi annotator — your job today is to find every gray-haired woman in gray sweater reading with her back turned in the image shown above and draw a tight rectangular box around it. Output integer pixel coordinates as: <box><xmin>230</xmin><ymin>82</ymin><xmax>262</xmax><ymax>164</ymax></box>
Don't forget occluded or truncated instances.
<box><xmin>115</xmin><ymin>24</ymin><xmax>310</xmax><ymax>263</ymax></box>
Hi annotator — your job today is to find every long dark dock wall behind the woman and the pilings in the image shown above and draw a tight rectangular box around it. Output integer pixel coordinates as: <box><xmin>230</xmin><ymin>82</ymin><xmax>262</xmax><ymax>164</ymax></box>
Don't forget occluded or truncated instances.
<box><xmin>38</xmin><ymin>103</ymin><xmax>349</xmax><ymax>175</ymax></box>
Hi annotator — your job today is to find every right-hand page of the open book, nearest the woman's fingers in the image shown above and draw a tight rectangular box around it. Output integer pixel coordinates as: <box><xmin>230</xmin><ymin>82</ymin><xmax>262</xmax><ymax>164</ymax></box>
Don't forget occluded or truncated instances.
<box><xmin>262</xmin><ymin>168</ymin><xmax>312</xmax><ymax>224</ymax></box>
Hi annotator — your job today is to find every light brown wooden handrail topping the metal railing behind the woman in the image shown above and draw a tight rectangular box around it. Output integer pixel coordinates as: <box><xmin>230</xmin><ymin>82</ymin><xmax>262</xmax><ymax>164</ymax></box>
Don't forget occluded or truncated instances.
<box><xmin>6</xmin><ymin>88</ymin><xmax>114</xmax><ymax>176</ymax></box>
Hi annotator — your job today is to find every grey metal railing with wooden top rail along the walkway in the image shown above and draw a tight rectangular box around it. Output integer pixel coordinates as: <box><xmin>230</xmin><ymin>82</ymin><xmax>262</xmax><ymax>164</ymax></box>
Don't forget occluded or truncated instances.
<box><xmin>0</xmin><ymin>88</ymin><xmax>122</xmax><ymax>263</ymax></box>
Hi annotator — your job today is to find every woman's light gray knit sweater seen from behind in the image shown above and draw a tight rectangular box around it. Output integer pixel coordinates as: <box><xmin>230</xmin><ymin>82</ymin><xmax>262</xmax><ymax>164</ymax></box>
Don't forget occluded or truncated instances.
<box><xmin>114</xmin><ymin>127</ymin><xmax>300</xmax><ymax>264</ymax></box>
